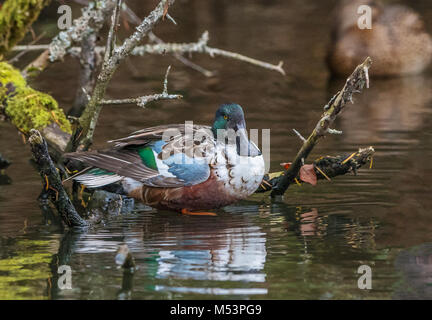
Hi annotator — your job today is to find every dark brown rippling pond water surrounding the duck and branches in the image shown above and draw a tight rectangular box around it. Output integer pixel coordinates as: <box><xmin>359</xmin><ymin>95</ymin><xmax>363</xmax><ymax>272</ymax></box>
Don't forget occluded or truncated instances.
<box><xmin>0</xmin><ymin>0</ymin><xmax>432</xmax><ymax>299</ymax></box>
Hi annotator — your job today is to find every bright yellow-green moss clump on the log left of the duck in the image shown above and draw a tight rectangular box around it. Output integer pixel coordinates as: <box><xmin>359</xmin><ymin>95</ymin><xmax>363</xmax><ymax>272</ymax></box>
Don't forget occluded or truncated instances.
<box><xmin>0</xmin><ymin>62</ymin><xmax>72</xmax><ymax>133</ymax></box>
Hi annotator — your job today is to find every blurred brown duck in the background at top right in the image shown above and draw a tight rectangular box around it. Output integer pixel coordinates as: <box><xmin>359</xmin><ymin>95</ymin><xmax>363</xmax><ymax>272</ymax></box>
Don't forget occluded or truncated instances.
<box><xmin>327</xmin><ymin>0</ymin><xmax>432</xmax><ymax>77</ymax></box>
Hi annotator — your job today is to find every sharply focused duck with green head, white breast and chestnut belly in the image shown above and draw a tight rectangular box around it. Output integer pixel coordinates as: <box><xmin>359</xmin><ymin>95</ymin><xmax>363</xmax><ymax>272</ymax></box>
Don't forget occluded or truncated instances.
<box><xmin>64</xmin><ymin>103</ymin><xmax>265</xmax><ymax>215</ymax></box>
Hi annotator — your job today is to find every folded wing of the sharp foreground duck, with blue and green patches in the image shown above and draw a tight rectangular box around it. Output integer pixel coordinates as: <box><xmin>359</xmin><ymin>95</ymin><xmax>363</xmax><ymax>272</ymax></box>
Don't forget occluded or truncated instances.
<box><xmin>65</xmin><ymin>124</ymin><xmax>215</xmax><ymax>187</ymax></box>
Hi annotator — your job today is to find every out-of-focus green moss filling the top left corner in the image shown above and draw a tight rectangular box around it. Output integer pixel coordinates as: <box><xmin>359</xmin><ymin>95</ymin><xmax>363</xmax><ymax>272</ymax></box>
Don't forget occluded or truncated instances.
<box><xmin>0</xmin><ymin>0</ymin><xmax>51</xmax><ymax>55</ymax></box>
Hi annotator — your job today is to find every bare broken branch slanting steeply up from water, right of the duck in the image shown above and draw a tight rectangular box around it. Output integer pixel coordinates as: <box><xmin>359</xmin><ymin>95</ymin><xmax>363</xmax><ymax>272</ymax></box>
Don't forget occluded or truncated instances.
<box><xmin>271</xmin><ymin>57</ymin><xmax>372</xmax><ymax>197</ymax></box>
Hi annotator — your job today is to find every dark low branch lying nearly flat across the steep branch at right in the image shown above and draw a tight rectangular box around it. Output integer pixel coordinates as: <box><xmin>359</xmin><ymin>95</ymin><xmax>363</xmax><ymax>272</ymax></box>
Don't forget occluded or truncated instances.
<box><xmin>255</xmin><ymin>147</ymin><xmax>375</xmax><ymax>193</ymax></box>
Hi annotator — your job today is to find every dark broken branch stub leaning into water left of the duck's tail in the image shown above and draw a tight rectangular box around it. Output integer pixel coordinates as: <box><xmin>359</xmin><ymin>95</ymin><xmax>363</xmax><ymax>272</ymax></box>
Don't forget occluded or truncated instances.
<box><xmin>29</xmin><ymin>129</ymin><xmax>88</xmax><ymax>227</ymax></box>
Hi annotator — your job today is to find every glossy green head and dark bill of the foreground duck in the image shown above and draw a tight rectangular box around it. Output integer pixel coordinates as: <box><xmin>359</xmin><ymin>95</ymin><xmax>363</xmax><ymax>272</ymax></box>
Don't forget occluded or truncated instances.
<box><xmin>212</xmin><ymin>103</ymin><xmax>261</xmax><ymax>157</ymax></box>
